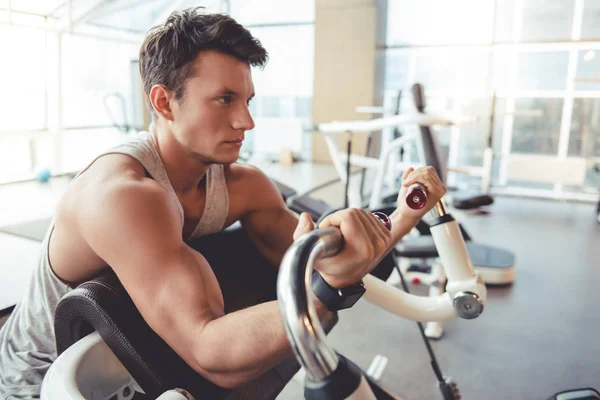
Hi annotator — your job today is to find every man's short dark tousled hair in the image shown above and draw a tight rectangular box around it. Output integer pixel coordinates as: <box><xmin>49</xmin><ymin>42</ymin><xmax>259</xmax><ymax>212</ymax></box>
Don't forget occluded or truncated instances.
<box><xmin>139</xmin><ymin>7</ymin><xmax>268</xmax><ymax>113</ymax></box>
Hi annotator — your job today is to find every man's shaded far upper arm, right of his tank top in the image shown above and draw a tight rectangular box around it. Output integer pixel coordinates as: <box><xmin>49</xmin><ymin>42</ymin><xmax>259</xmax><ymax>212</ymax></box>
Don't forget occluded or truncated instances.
<box><xmin>241</xmin><ymin>169</ymin><xmax>298</xmax><ymax>266</ymax></box>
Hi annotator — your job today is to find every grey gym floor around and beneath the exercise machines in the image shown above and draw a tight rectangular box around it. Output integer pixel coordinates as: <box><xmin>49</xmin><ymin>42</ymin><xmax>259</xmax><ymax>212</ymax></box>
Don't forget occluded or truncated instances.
<box><xmin>0</xmin><ymin>160</ymin><xmax>600</xmax><ymax>400</ymax></box>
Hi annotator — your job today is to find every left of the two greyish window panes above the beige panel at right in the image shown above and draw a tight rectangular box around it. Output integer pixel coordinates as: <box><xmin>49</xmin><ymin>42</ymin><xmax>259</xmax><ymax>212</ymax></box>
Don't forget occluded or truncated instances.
<box><xmin>511</xmin><ymin>99</ymin><xmax>563</xmax><ymax>154</ymax></box>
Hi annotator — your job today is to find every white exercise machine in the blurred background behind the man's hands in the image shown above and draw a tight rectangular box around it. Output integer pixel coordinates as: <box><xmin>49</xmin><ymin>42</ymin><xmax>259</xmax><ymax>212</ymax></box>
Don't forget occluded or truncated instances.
<box><xmin>310</xmin><ymin>84</ymin><xmax>515</xmax><ymax>339</ymax></box>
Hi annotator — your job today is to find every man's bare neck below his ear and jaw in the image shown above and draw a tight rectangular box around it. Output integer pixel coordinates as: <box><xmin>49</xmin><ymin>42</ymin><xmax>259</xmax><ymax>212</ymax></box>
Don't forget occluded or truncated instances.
<box><xmin>150</xmin><ymin>124</ymin><xmax>210</xmax><ymax>194</ymax></box>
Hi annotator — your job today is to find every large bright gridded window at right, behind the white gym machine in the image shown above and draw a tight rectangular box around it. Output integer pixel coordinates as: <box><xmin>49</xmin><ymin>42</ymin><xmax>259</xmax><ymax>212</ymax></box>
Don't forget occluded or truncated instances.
<box><xmin>384</xmin><ymin>0</ymin><xmax>600</xmax><ymax>198</ymax></box>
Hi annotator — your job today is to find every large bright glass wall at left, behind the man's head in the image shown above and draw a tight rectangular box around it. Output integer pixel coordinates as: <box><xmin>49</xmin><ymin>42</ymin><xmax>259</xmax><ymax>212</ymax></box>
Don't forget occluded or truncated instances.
<box><xmin>0</xmin><ymin>0</ymin><xmax>314</xmax><ymax>182</ymax></box>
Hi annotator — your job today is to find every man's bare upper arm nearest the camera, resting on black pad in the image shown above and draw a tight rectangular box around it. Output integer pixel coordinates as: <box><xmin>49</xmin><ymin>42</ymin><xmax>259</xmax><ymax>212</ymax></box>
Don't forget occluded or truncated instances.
<box><xmin>79</xmin><ymin>184</ymin><xmax>223</xmax><ymax>372</ymax></box>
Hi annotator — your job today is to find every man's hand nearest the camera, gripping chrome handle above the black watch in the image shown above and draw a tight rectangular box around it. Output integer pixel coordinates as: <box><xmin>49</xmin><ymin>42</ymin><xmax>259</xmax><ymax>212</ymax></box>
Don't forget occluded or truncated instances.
<box><xmin>294</xmin><ymin>208</ymin><xmax>391</xmax><ymax>288</ymax></box>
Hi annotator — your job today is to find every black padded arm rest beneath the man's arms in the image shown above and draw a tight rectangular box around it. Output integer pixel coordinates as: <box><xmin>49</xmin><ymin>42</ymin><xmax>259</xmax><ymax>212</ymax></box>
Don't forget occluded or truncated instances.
<box><xmin>55</xmin><ymin>229</ymin><xmax>337</xmax><ymax>400</ymax></box>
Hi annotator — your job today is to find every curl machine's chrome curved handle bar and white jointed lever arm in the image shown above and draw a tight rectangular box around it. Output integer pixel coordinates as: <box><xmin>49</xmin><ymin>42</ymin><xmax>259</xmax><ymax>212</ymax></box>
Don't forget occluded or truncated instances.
<box><xmin>277</xmin><ymin>185</ymin><xmax>486</xmax><ymax>400</ymax></box>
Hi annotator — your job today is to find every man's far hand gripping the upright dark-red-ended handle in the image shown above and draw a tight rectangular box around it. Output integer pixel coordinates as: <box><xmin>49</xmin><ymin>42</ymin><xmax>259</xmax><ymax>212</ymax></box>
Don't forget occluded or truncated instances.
<box><xmin>396</xmin><ymin>167</ymin><xmax>446</xmax><ymax>222</ymax></box>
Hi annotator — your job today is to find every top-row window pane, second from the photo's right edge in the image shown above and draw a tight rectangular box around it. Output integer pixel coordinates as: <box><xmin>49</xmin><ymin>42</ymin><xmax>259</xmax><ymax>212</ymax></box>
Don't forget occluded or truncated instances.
<box><xmin>521</xmin><ymin>0</ymin><xmax>575</xmax><ymax>41</ymax></box>
